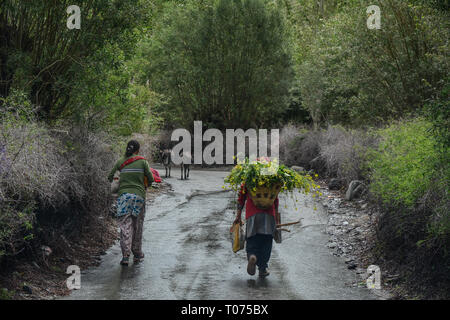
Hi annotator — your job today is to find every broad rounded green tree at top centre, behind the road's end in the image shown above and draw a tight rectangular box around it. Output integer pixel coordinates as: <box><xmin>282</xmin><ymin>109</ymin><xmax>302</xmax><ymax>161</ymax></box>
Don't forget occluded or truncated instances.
<box><xmin>143</xmin><ymin>0</ymin><xmax>293</xmax><ymax>129</ymax></box>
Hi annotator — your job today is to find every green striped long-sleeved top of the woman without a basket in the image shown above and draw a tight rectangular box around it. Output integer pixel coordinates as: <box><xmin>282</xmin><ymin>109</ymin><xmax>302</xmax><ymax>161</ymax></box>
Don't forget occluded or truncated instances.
<box><xmin>108</xmin><ymin>154</ymin><xmax>154</xmax><ymax>199</ymax></box>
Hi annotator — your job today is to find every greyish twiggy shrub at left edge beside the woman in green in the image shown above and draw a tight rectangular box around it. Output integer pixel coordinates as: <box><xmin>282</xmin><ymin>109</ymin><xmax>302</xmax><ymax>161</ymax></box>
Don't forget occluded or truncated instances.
<box><xmin>0</xmin><ymin>105</ymin><xmax>118</xmax><ymax>258</ymax></box>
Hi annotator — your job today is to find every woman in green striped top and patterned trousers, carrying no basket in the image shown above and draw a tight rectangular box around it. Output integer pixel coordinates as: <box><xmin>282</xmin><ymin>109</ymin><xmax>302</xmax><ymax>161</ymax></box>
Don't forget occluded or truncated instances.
<box><xmin>108</xmin><ymin>140</ymin><xmax>153</xmax><ymax>266</ymax></box>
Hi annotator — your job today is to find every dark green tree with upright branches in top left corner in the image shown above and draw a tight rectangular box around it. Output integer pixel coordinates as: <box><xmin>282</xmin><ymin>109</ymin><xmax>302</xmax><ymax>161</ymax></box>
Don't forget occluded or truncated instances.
<box><xmin>0</xmin><ymin>0</ymin><xmax>152</xmax><ymax>120</ymax></box>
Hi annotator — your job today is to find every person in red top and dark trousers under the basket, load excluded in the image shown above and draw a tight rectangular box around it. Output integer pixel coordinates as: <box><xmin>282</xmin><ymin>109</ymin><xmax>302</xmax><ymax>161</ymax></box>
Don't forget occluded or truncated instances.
<box><xmin>234</xmin><ymin>186</ymin><xmax>279</xmax><ymax>278</ymax></box>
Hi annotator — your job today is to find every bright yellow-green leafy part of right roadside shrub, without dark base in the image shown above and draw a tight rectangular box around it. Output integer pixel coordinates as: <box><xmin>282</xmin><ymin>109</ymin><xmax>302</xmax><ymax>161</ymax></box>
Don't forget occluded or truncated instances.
<box><xmin>368</xmin><ymin>119</ymin><xmax>438</xmax><ymax>208</ymax></box>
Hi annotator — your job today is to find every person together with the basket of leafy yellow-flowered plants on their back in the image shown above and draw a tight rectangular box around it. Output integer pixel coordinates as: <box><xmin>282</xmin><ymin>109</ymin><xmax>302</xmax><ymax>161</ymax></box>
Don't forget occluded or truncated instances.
<box><xmin>225</xmin><ymin>158</ymin><xmax>319</xmax><ymax>278</ymax></box>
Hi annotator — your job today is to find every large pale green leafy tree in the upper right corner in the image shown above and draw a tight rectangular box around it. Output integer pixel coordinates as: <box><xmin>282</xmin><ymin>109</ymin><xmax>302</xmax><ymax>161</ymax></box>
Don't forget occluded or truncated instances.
<box><xmin>297</xmin><ymin>0</ymin><xmax>450</xmax><ymax>126</ymax></box>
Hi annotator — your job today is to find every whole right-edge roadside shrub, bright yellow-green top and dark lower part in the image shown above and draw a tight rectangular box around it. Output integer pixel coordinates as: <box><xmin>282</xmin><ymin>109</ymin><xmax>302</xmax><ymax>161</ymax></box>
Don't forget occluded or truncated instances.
<box><xmin>368</xmin><ymin>119</ymin><xmax>450</xmax><ymax>296</ymax></box>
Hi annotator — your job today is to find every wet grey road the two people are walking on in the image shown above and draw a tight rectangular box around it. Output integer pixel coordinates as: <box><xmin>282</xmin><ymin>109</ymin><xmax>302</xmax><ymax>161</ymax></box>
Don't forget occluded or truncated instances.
<box><xmin>66</xmin><ymin>170</ymin><xmax>376</xmax><ymax>300</ymax></box>
